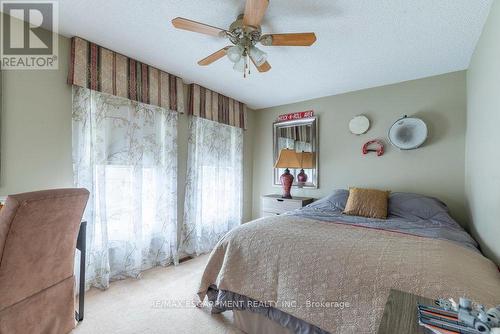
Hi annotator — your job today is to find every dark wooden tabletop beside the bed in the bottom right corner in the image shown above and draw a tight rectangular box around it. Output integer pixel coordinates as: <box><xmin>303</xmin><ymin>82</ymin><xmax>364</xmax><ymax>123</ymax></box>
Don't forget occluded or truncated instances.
<box><xmin>377</xmin><ymin>290</ymin><xmax>434</xmax><ymax>334</ymax></box>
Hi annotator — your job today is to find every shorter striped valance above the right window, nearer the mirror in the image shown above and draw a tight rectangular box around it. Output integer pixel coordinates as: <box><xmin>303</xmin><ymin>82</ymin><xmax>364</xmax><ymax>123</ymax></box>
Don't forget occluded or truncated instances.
<box><xmin>188</xmin><ymin>84</ymin><xmax>247</xmax><ymax>129</ymax></box>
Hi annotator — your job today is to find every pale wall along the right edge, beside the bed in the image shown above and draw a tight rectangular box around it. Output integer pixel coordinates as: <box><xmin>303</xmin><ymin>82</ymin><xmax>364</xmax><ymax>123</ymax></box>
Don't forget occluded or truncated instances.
<box><xmin>465</xmin><ymin>1</ymin><xmax>500</xmax><ymax>264</ymax></box>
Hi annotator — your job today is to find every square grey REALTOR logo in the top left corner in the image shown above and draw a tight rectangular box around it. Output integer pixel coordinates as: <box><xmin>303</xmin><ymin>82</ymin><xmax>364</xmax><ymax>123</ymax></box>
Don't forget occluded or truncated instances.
<box><xmin>0</xmin><ymin>1</ymin><xmax>58</xmax><ymax>70</ymax></box>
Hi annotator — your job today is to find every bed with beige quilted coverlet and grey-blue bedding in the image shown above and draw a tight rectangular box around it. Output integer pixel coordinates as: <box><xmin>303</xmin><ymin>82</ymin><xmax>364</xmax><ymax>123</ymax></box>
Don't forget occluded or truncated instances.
<box><xmin>198</xmin><ymin>190</ymin><xmax>500</xmax><ymax>334</ymax></box>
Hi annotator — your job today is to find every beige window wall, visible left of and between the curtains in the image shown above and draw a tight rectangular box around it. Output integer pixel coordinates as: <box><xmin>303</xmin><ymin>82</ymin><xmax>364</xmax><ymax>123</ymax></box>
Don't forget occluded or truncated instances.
<box><xmin>0</xmin><ymin>27</ymin><xmax>253</xmax><ymax>221</ymax></box>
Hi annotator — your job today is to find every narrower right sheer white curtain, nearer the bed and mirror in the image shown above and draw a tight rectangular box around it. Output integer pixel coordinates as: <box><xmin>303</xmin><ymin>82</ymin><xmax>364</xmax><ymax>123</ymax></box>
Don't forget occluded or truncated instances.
<box><xmin>182</xmin><ymin>117</ymin><xmax>243</xmax><ymax>254</ymax></box>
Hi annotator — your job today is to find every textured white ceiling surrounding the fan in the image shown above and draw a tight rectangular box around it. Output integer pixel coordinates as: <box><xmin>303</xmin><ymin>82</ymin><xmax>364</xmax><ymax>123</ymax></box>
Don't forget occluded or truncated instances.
<box><xmin>55</xmin><ymin>0</ymin><xmax>493</xmax><ymax>108</ymax></box>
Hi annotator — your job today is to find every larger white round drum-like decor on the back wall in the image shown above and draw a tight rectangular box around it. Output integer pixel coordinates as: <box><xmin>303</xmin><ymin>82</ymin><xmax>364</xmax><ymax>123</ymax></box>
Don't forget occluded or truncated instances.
<box><xmin>389</xmin><ymin>116</ymin><xmax>427</xmax><ymax>150</ymax></box>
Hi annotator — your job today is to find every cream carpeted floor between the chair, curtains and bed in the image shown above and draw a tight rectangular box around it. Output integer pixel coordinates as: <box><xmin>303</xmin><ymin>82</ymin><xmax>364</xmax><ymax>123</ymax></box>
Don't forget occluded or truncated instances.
<box><xmin>72</xmin><ymin>256</ymin><xmax>242</xmax><ymax>334</ymax></box>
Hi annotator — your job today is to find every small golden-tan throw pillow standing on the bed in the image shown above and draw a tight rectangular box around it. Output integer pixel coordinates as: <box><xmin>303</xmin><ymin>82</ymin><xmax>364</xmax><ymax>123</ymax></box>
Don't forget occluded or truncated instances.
<box><xmin>343</xmin><ymin>188</ymin><xmax>390</xmax><ymax>219</ymax></box>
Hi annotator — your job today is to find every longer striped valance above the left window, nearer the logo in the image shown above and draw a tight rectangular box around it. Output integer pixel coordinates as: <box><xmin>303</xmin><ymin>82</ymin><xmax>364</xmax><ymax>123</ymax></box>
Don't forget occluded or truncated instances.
<box><xmin>68</xmin><ymin>37</ymin><xmax>184</xmax><ymax>112</ymax></box>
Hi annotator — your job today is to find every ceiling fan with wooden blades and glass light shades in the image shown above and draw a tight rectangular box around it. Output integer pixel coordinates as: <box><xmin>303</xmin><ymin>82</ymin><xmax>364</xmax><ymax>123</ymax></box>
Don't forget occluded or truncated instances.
<box><xmin>172</xmin><ymin>0</ymin><xmax>316</xmax><ymax>77</ymax></box>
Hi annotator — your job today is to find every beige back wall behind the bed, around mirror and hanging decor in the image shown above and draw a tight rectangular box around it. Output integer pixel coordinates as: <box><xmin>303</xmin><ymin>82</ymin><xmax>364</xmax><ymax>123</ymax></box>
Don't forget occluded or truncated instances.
<box><xmin>253</xmin><ymin>72</ymin><xmax>466</xmax><ymax>225</ymax></box>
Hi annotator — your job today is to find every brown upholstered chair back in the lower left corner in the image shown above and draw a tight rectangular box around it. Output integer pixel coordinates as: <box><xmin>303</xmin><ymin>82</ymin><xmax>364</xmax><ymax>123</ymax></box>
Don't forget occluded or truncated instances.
<box><xmin>0</xmin><ymin>189</ymin><xmax>89</xmax><ymax>334</ymax></box>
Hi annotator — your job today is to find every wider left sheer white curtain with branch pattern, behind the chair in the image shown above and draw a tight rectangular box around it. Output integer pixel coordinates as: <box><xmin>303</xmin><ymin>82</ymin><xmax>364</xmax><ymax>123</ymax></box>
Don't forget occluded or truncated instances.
<box><xmin>73</xmin><ymin>87</ymin><xmax>177</xmax><ymax>288</ymax></box>
